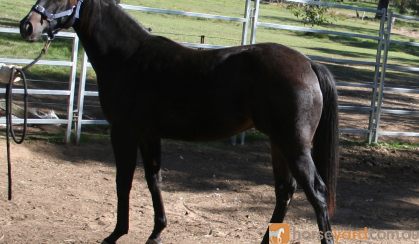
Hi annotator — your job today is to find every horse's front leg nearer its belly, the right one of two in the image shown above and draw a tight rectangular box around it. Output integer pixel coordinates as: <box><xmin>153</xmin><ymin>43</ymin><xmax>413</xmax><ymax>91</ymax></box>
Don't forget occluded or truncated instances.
<box><xmin>140</xmin><ymin>138</ymin><xmax>167</xmax><ymax>244</ymax></box>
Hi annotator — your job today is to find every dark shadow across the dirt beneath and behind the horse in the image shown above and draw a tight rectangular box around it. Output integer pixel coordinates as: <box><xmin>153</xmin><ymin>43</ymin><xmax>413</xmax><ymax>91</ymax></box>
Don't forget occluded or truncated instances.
<box><xmin>25</xmin><ymin>139</ymin><xmax>419</xmax><ymax>230</ymax></box>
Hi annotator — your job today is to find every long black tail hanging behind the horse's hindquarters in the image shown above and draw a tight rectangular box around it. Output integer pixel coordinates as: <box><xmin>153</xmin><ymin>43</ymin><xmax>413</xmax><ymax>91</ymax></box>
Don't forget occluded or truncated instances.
<box><xmin>311</xmin><ymin>62</ymin><xmax>339</xmax><ymax>216</ymax></box>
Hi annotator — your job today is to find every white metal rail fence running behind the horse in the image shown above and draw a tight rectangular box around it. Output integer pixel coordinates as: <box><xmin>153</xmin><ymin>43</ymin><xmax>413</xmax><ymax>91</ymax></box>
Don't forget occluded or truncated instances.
<box><xmin>0</xmin><ymin>0</ymin><xmax>419</xmax><ymax>142</ymax></box>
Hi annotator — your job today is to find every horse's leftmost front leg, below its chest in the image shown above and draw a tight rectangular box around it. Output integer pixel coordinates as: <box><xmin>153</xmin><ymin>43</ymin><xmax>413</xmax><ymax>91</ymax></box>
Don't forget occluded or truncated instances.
<box><xmin>102</xmin><ymin>125</ymin><xmax>138</xmax><ymax>244</ymax></box>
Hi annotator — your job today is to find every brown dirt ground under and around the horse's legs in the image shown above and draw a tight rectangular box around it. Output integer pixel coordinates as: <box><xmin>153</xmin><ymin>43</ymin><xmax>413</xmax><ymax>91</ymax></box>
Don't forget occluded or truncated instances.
<box><xmin>0</xmin><ymin>136</ymin><xmax>419</xmax><ymax>244</ymax></box>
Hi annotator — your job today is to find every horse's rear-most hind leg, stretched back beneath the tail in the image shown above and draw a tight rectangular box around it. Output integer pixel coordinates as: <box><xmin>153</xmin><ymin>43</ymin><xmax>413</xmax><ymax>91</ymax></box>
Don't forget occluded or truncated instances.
<box><xmin>284</xmin><ymin>147</ymin><xmax>333</xmax><ymax>244</ymax></box>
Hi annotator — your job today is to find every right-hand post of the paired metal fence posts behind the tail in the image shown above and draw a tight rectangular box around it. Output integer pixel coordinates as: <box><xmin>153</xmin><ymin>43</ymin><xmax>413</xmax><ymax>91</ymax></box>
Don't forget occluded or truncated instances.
<box><xmin>374</xmin><ymin>11</ymin><xmax>393</xmax><ymax>143</ymax></box>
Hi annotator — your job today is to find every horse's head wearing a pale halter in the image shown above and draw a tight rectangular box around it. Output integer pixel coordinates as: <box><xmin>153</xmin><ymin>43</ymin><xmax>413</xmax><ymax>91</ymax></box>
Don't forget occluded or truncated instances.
<box><xmin>20</xmin><ymin>0</ymin><xmax>87</xmax><ymax>41</ymax></box>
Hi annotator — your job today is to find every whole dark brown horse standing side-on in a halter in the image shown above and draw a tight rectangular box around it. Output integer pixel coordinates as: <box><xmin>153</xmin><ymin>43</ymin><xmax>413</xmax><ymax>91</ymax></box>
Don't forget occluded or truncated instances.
<box><xmin>20</xmin><ymin>0</ymin><xmax>338</xmax><ymax>243</ymax></box>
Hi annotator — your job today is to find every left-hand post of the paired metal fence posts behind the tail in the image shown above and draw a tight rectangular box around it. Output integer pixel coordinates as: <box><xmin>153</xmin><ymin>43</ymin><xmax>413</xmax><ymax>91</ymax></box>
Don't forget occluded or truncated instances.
<box><xmin>368</xmin><ymin>9</ymin><xmax>387</xmax><ymax>144</ymax></box>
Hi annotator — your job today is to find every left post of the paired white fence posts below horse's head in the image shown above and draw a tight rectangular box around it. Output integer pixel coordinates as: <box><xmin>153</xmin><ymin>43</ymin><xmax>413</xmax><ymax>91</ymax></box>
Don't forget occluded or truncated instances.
<box><xmin>65</xmin><ymin>36</ymin><xmax>79</xmax><ymax>143</ymax></box>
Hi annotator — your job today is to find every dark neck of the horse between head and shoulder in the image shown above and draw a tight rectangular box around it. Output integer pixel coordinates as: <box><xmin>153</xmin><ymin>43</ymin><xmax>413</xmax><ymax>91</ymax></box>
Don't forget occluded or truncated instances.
<box><xmin>74</xmin><ymin>0</ymin><xmax>149</xmax><ymax>69</ymax></box>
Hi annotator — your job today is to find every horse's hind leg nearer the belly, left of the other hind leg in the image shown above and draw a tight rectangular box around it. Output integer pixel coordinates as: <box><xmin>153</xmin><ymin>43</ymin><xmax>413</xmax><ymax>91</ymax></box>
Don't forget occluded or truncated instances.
<box><xmin>262</xmin><ymin>143</ymin><xmax>297</xmax><ymax>243</ymax></box>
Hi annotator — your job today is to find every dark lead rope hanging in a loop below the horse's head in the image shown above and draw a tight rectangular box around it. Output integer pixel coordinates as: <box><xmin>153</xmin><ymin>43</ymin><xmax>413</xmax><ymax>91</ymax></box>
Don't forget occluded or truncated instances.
<box><xmin>6</xmin><ymin>38</ymin><xmax>52</xmax><ymax>201</ymax></box>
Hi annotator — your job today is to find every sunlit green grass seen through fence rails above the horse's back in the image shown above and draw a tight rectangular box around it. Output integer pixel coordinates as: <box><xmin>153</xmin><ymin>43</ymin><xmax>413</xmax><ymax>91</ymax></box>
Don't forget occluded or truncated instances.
<box><xmin>126</xmin><ymin>0</ymin><xmax>419</xmax><ymax>66</ymax></box>
